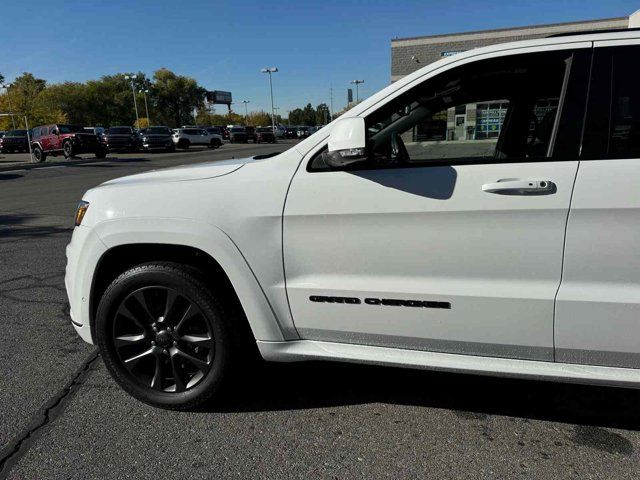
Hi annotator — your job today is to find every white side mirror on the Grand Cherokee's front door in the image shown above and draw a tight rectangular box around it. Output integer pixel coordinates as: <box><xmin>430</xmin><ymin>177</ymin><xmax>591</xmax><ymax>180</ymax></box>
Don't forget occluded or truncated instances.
<box><xmin>324</xmin><ymin>117</ymin><xmax>367</xmax><ymax>168</ymax></box>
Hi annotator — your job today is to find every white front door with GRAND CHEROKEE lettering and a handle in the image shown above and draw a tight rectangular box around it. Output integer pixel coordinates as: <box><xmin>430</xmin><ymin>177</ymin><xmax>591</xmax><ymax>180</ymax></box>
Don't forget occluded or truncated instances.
<box><xmin>283</xmin><ymin>46</ymin><xmax>590</xmax><ymax>360</ymax></box>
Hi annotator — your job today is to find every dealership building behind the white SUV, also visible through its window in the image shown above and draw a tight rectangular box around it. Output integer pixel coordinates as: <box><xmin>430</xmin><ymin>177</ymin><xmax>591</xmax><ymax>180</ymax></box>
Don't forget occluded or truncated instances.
<box><xmin>391</xmin><ymin>10</ymin><xmax>640</xmax><ymax>140</ymax></box>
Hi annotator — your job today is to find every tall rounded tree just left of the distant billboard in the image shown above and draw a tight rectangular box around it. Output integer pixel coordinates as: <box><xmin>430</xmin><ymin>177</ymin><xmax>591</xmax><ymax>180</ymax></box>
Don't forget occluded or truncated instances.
<box><xmin>149</xmin><ymin>68</ymin><xmax>206</xmax><ymax>127</ymax></box>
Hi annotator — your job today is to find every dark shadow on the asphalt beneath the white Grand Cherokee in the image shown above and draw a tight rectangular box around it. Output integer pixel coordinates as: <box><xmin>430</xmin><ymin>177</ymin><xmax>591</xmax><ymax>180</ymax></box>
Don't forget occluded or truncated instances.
<box><xmin>208</xmin><ymin>362</ymin><xmax>640</xmax><ymax>430</ymax></box>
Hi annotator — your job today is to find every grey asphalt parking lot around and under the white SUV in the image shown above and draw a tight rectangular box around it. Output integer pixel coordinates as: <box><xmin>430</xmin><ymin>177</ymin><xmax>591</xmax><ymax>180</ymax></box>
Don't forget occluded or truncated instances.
<box><xmin>0</xmin><ymin>144</ymin><xmax>640</xmax><ymax>479</ymax></box>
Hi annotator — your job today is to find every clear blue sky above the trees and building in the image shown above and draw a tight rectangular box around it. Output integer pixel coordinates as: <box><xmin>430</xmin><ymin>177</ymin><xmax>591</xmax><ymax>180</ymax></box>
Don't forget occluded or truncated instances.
<box><xmin>0</xmin><ymin>0</ymin><xmax>640</xmax><ymax>116</ymax></box>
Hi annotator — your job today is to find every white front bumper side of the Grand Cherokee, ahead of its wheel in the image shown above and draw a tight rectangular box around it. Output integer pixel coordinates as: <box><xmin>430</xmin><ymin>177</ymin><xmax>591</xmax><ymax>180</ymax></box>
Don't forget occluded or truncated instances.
<box><xmin>64</xmin><ymin>226</ymin><xmax>107</xmax><ymax>343</ymax></box>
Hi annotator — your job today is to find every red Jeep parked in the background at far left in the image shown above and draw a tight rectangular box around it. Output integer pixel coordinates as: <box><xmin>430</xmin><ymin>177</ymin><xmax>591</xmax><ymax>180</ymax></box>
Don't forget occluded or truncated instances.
<box><xmin>31</xmin><ymin>124</ymin><xmax>107</xmax><ymax>162</ymax></box>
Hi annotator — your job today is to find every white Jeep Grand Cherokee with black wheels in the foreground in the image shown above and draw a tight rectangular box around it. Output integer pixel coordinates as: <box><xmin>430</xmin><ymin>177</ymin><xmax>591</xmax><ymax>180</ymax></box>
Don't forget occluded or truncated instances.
<box><xmin>66</xmin><ymin>31</ymin><xmax>640</xmax><ymax>409</ymax></box>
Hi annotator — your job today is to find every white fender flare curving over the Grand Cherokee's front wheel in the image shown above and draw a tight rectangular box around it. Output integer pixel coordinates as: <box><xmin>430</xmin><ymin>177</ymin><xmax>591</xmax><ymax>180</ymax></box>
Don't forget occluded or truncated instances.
<box><xmin>94</xmin><ymin>217</ymin><xmax>286</xmax><ymax>341</ymax></box>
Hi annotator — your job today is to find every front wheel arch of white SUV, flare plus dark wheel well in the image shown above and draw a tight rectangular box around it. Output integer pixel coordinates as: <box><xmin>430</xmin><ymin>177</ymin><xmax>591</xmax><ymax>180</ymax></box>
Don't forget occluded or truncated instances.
<box><xmin>89</xmin><ymin>219</ymin><xmax>285</xmax><ymax>341</ymax></box>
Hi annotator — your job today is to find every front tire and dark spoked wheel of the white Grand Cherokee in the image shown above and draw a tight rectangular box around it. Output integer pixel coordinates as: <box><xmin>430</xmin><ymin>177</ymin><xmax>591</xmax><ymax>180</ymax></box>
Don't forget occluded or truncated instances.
<box><xmin>95</xmin><ymin>262</ymin><xmax>238</xmax><ymax>410</ymax></box>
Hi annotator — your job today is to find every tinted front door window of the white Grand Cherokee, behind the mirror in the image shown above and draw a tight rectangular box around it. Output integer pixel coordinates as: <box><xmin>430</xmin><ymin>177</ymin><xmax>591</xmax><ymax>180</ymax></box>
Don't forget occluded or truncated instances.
<box><xmin>310</xmin><ymin>51</ymin><xmax>584</xmax><ymax>170</ymax></box>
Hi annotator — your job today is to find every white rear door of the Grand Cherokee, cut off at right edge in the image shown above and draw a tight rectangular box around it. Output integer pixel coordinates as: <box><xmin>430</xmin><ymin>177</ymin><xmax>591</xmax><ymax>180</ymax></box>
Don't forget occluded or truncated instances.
<box><xmin>555</xmin><ymin>40</ymin><xmax>640</xmax><ymax>368</ymax></box>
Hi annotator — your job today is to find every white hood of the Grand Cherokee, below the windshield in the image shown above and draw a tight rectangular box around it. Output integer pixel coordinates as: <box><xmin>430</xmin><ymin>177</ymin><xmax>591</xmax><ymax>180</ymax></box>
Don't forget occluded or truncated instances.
<box><xmin>101</xmin><ymin>157</ymin><xmax>253</xmax><ymax>187</ymax></box>
